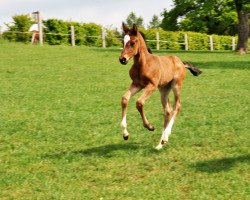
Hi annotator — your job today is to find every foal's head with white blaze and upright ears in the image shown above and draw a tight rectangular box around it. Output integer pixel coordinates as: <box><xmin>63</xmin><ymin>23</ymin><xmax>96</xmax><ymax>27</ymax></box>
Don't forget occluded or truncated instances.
<box><xmin>119</xmin><ymin>23</ymin><xmax>142</xmax><ymax>65</ymax></box>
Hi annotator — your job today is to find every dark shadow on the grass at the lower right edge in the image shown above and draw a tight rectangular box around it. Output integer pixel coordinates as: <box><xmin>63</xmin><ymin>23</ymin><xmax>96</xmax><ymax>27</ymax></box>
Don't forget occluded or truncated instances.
<box><xmin>190</xmin><ymin>154</ymin><xmax>250</xmax><ymax>173</ymax></box>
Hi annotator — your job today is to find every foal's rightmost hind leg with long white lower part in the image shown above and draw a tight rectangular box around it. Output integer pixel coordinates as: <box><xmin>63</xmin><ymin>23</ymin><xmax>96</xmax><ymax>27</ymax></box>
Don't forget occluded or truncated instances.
<box><xmin>156</xmin><ymin>80</ymin><xmax>182</xmax><ymax>150</ymax></box>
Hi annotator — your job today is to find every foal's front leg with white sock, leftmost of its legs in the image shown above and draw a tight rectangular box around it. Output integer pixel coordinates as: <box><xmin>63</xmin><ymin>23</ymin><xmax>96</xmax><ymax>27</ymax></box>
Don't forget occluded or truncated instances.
<box><xmin>121</xmin><ymin>83</ymin><xmax>141</xmax><ymax>140</ymax></box>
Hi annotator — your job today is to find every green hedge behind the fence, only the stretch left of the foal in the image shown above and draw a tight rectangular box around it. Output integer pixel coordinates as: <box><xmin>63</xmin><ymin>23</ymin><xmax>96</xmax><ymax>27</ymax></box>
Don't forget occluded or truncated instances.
<box><xmin>3</xmin><ymin>15</ymin><xmax>120</xmax><ymax>47</ymax></box>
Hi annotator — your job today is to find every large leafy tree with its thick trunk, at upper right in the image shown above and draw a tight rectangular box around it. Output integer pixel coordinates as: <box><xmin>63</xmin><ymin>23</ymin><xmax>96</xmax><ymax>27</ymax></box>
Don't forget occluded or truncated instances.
<box><xmin>161</xmin><ymin>0</ymin><xmax>250</xmax><ymax>53</ymax></box>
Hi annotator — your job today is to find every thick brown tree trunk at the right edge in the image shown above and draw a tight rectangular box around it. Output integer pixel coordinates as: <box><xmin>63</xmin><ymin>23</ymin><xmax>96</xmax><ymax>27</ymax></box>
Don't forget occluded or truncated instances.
<box><xmin>234</xmin><ymin>0</ymin><xmax>250</xmax><ymax>53</ymax></box>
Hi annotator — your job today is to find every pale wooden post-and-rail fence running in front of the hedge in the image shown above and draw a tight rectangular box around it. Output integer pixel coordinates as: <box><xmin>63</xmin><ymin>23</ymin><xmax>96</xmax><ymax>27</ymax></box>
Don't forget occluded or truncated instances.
<box><xmin>0</xmin><ymin>26</ymin><xmax>236</xmax><ymax>51</ymax></box>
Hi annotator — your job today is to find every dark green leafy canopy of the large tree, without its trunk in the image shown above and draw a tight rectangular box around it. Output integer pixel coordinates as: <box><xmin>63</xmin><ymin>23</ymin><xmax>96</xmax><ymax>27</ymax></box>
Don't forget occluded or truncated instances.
<box><xmin>161</xmin><ymin>0</ymin><xmax>237</xmax><ymax>35</ymax></box>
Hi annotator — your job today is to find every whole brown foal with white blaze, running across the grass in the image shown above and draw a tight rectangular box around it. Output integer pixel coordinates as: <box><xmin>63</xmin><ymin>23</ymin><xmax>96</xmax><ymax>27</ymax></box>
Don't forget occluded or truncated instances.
<box><xmin>119</xmin><ymin>24</ymin><xmax>201</xmax><ymax>150</ymax></box>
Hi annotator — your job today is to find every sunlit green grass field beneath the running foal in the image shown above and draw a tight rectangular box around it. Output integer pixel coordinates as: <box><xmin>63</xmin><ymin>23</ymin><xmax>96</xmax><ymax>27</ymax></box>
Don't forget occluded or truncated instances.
<box><xmin>0</xmin><ymin>43</ymin><xmax>250</xmax><ymax>200</ymax></box>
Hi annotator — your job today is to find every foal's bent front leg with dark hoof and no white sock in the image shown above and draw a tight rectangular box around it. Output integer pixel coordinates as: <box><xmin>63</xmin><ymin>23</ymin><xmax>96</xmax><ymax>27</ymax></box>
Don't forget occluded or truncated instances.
<box><xmin>136</xmin><ymin>84</ymin><xmax>157</xmax><ymax>131</ymax></box>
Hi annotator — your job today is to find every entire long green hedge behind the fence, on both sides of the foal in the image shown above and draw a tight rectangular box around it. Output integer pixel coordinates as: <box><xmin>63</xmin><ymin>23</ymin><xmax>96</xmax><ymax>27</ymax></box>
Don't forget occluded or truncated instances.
<box><xmin>3</xmin><ymin>15</ymin><xmax>250</xmax><ymax>50</ymax></box>
